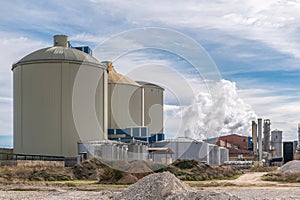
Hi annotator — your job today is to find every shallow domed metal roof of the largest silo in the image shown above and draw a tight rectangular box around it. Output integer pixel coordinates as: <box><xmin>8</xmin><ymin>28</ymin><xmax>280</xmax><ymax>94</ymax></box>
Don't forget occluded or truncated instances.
<box><xmin>12</xmin><ymin>46</ymin><xmax>104</xmax><ymax>70</ymax></box>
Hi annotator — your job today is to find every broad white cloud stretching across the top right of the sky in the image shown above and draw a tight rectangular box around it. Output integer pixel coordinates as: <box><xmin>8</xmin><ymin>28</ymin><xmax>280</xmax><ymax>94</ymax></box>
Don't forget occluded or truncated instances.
<box><xmin>89</xmin><ymin>0</ymin><xmax>300</xmax><ymax>58</ymax></box>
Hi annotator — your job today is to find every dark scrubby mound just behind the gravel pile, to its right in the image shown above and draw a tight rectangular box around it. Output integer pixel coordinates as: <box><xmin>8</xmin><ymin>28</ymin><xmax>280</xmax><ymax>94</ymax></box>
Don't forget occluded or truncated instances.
<box><xmin>160</xmin><ymin>160</ymin><xmax>237</xmax><ymax>181</ymax></box>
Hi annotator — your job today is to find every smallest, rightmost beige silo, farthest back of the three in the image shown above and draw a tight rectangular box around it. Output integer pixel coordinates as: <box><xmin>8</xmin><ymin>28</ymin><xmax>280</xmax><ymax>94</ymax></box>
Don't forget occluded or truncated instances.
<box><xmin>138</xmin><ymin>81</ymin><xmax>164</xmax><ymax>135</ymax></box>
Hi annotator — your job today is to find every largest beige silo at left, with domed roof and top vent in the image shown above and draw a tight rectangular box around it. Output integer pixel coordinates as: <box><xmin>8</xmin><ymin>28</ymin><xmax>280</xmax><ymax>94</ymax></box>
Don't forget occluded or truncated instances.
<box><xmin>12</xmin><ymin>35</ymin><xmax>107</xmax><ymax>157</ymax></box>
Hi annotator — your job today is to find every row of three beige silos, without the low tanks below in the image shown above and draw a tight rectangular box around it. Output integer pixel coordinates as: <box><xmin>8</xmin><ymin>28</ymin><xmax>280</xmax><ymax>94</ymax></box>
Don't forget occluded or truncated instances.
<box><xmin>12</xmin><ymin>35</ymin><xmax>164</xmax><ymax>157</ymax></box>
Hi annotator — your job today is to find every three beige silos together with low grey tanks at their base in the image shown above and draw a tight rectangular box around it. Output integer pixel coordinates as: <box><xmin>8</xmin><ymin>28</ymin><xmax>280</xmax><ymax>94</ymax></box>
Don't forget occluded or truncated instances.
<box><xmin>12</xmin><ymin>35</ymin><xmax>228</xmax><ymax>165</ymax></box>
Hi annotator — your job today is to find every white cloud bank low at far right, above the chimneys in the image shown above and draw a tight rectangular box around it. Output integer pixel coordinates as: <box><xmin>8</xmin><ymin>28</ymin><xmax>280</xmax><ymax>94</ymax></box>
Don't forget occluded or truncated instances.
<box><xmin>238</xmin><ymin>88</ymin><xmax>300</xmax><ymax>140</ymax></box>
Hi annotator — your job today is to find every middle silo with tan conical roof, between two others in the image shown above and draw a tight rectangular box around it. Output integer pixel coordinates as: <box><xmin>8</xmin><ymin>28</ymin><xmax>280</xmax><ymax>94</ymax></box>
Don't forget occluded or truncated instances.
<box><xmin>103</xmin><ymin>62</ymin><xmax>143</xmax><ymax>129</ymax></box>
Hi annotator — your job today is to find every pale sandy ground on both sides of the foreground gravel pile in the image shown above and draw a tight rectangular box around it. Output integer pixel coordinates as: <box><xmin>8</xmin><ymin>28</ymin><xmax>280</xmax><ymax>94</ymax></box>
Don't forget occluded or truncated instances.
<box><xmin>0</xmin><ymin>173</ymin><xmax>300</xmax><ymax>200</ymax></box>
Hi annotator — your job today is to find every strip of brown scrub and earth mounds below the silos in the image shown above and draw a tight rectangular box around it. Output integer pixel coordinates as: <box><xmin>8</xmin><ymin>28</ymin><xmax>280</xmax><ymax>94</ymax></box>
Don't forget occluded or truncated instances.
<box><xmin>0</xmin><ymin>158</ymin><xmax>238</xmax><ymax>187</ymax></box>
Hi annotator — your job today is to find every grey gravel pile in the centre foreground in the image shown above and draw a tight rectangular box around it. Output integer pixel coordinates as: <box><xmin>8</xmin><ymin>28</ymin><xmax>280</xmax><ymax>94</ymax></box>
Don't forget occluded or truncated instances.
<box><xmin>113</xmin><ymin>172</ymin><xmax>239</xmax><ymax>200</ymax></box>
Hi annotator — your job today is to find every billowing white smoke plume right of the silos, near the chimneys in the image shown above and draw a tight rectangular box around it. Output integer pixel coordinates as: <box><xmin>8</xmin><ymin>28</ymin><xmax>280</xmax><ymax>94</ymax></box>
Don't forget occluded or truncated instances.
<box><xmin>165</xmin><ymin>80</ymin><xmax>257</xmax><ymax>139</ymax></box>
